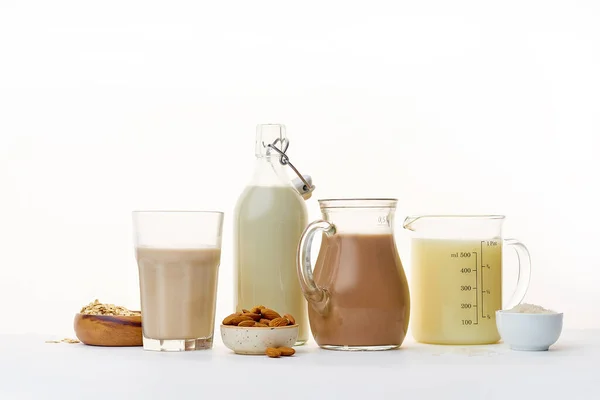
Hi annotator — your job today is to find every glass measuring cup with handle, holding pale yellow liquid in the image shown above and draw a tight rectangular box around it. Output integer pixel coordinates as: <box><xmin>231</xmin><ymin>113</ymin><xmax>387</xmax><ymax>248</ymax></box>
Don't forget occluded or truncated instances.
<box><xmin>403</xmin><ymin>215</ymin><xmax>531</xmax><ymax>344</ymax></box>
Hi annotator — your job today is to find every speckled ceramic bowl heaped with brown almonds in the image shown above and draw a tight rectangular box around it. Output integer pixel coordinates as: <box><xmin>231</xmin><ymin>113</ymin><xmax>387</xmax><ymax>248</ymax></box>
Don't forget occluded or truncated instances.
<box><xmin>221</xmin><ymin>306</ymin><xmax>298</xmax><ymax>355</ymax></box>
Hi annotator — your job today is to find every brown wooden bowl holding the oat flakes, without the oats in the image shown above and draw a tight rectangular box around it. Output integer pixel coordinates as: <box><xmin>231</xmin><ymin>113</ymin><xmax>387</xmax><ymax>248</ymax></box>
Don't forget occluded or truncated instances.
<box><xmin>73</xmin><ymin>314</ymin><xmax>142</xmax><ymax>347</ymax></box>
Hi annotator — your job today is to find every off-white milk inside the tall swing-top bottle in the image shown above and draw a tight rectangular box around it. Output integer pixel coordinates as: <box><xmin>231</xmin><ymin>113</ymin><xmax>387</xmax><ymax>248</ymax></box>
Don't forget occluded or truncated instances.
<box><xmin>234</xmin><ymin>186</ymin><xmax>308</xmax><ymax>342</ymax></box>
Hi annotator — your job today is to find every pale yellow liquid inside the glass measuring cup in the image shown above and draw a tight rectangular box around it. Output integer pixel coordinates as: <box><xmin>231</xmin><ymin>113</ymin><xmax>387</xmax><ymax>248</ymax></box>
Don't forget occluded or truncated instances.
<box><xmin>411</xmin><ymin>239</ymin><xmax>502</xmax><ymax>344</ymax></box>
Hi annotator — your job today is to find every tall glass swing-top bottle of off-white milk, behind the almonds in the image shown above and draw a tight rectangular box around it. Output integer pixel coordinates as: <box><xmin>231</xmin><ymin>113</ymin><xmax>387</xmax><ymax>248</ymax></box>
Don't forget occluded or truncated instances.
<box><xmin>234</xmin><ymin>124</ymin><xmax>314</xmax><ymax>344</ymax></box>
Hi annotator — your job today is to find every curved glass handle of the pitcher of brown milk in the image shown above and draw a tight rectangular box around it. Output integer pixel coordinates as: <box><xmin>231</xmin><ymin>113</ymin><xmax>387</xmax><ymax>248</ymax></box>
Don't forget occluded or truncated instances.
<box><xmin>296</xmin><ymin>220</ymin><xmax>335</xmax><ymax>315</ymax></box>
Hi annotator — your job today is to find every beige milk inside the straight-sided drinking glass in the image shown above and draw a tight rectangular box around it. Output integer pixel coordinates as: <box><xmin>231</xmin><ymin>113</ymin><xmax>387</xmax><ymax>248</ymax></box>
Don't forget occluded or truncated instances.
<box><xmin>136</xmin><ymin>247</ymin><xmax>221</xmax><ymax>340</ymax></box>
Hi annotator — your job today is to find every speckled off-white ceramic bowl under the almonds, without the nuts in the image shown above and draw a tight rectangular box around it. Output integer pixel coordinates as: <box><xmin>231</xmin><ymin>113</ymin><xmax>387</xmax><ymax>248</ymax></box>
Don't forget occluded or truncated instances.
<box><xmin>221</xmin><ymin>324</ymin><xmax>298</xmax><ymax>355</ymax></box>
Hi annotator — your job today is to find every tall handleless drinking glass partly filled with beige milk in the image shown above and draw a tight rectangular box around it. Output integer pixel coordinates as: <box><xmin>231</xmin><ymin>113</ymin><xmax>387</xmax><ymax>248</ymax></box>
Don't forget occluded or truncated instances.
<box><xmin>133</xmin><ymin>211</ymin><xmax>223</xmax><ymax>351</ymax></box>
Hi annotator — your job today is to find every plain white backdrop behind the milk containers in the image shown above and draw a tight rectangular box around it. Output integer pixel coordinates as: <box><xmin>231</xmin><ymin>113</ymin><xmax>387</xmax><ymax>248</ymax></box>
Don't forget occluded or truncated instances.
<box><xmin>0</xmin><ymin>0</ymin><xmax>600</xmax><ymax>336</ymax></box>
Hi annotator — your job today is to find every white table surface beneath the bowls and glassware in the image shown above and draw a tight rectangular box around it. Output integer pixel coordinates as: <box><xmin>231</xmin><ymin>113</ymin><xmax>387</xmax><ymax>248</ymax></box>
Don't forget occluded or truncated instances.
<box><xmin>0</xmin><ymin>330</ymin><xmax>600</xmax><ymax>400</ymax></box>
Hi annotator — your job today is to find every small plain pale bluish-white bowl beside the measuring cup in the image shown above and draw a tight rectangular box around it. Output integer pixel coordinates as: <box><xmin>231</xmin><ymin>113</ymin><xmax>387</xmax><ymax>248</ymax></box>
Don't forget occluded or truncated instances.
<box><xmin>496</xmin><ymin>310</ymin><xmax>563</xmax><ymax>351</ymax></box>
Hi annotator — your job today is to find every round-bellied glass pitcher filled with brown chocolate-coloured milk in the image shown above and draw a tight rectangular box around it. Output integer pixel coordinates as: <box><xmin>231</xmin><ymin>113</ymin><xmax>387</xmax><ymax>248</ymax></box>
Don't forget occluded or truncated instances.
<box><xmin>297</xmin><ymin>199</ymin><xmax>410</xmax><ymax>350</ymax></box>
